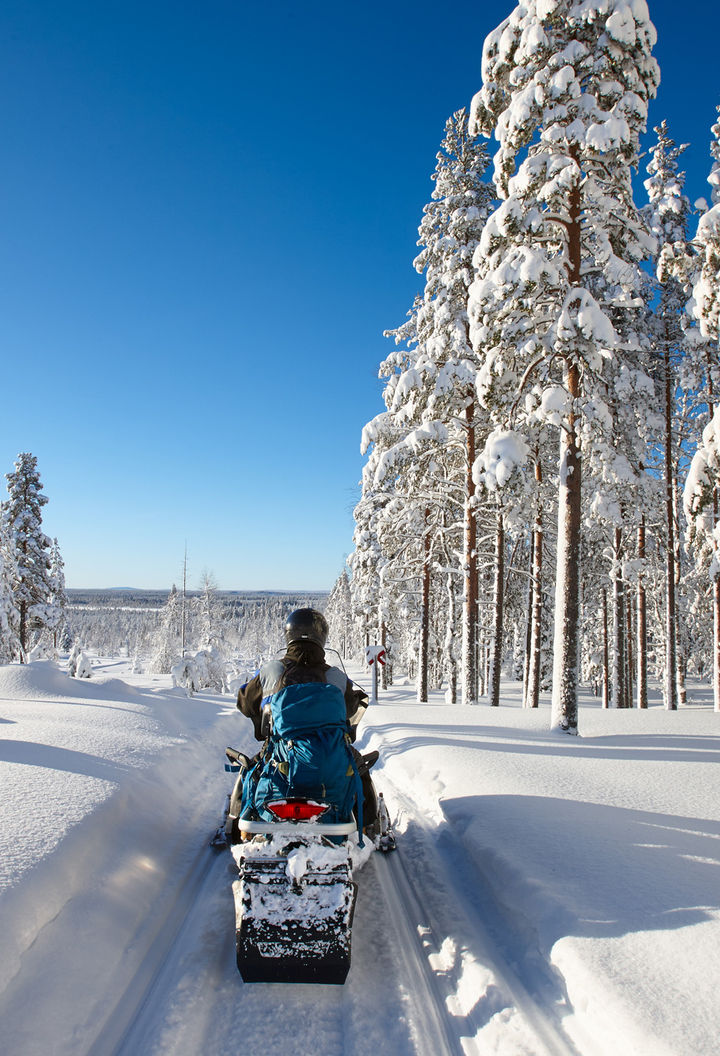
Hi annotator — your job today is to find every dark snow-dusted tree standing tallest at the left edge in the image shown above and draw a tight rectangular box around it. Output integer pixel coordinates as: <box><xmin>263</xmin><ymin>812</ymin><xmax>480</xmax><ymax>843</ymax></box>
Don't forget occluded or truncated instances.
<box><xmin>3</xmin><ymin>452</ymin><xmax>53</xmax><ymax>661</ymax></box>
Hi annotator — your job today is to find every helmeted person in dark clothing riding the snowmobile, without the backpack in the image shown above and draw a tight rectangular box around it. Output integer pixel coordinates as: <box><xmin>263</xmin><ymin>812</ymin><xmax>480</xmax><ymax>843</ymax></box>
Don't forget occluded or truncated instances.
<box><xmin>238</xmin><ymin>608</ymin><xmax>377</xmax><ymax>830</ymax></box>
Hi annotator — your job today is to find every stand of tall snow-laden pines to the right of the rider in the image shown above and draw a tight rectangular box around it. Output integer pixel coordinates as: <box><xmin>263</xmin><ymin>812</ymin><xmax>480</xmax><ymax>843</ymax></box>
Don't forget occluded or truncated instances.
<box><xmin>328</xmin><ymin>0</ymin><xmax>720</xmax><ymax>734</ymax></box>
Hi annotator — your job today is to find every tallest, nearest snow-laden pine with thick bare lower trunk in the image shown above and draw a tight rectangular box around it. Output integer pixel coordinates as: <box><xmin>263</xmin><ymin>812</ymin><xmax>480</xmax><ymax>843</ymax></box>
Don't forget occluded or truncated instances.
<box><xmin>464</xmin><ymin>0</ymin><xmax>659</xmax><ymax>733</ymax></box>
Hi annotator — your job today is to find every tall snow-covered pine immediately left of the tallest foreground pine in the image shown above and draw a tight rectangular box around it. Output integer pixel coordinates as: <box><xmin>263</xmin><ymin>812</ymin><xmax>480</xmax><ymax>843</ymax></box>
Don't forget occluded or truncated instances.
<box><xmin>381</xmin><ymin>110</ymin><xmax>493</xmax><ymax>703</ymax></box>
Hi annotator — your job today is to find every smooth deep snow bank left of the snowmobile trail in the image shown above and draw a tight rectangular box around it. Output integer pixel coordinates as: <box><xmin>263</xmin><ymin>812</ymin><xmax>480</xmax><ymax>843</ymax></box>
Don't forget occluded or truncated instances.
<box><xmin>0</xmin><ymin>661</ymin><xmax>247</xmax><ymax>1004</ymax></box>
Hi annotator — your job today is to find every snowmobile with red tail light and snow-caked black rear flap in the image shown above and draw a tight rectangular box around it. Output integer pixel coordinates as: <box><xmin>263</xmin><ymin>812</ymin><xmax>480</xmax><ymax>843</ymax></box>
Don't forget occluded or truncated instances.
<box><xmin>214</xmin><ymin>748</ymin><xmax>395</xmax><ymax>984</ymax></box>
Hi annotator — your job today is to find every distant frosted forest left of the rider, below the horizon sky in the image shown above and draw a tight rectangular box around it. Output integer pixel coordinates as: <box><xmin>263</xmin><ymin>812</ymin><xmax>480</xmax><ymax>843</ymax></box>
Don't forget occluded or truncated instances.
<box><xmin>0</xmin><ymin>452</ymin><xmax>327</xmax><ymax>693</ymax></box>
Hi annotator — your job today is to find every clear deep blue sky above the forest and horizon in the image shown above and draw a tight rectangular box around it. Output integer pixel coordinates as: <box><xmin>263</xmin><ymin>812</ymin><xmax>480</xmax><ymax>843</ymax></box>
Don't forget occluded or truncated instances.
<box><xmin>0</xmin><ymin>0</ymin><xmax>720</xmax><ymax>589</ymax></box>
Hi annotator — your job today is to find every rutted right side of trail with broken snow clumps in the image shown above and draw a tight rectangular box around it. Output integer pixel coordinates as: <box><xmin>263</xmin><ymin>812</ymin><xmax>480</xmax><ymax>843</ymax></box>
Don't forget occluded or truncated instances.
<box><xmin>377</xmin><ymin>781</ymin><xmax>576</xmax><ymax>1056</ymax></box>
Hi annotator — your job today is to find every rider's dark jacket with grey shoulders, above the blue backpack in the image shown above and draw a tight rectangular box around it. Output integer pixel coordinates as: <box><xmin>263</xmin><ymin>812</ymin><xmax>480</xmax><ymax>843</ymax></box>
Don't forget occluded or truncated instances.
<box><xmin>238</xmin><ymin>642</ymin><xmax>367</xmax><ymax>740</ymax></box>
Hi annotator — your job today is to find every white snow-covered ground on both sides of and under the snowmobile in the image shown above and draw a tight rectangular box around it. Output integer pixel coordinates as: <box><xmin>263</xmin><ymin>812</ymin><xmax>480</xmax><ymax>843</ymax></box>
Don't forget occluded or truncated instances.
<box><xmin>0</xmin><ymin>658</ymin><xmax>720</xmax><ymax>1056</ymax></box>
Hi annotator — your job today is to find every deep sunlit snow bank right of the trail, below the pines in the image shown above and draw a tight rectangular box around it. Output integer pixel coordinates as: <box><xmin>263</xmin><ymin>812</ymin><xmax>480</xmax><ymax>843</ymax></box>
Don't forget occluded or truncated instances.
<box><xmin>356</xmin><ymin>686</ymin><xmax>720</xmax><ymax>1056</ymax></box>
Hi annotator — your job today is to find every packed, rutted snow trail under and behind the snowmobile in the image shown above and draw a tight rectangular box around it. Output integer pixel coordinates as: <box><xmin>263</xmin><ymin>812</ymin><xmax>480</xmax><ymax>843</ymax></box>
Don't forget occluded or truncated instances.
<box><xmin>79</xmin><ymin>782</ymin><xmax>576</xmax><ymax>1056</ymax></box>
